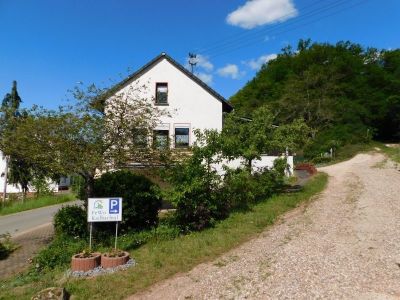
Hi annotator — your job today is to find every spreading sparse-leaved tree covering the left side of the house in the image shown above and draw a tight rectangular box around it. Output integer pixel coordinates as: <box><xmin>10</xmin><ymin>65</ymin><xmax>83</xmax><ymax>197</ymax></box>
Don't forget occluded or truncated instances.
<box><xmin>1</xmin><ymin>85</ymin><xmax>165</xmax><ymax>196</ymax></box>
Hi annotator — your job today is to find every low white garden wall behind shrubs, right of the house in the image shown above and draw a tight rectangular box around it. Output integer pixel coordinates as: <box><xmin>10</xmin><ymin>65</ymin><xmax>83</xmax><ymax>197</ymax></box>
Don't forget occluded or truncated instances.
<box><xmin>213</xmin><ymin>155</ymin><xmax>293</xmax><ymax>176</ymax></box>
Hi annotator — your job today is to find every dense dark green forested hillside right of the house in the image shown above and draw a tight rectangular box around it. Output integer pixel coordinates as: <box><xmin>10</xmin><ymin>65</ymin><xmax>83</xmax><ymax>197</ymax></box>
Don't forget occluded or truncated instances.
<box><xmin>230</xmin><ymin>40</ymin><xmax>400</xmax><ymax>157</ymax></box>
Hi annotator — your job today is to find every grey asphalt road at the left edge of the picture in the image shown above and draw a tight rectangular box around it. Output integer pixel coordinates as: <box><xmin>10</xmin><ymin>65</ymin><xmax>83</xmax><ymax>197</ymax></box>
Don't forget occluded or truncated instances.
<box><xmin>0</xmin><ymin>201</ymin><xmax>79</xmax><ymax>237</ymax></box>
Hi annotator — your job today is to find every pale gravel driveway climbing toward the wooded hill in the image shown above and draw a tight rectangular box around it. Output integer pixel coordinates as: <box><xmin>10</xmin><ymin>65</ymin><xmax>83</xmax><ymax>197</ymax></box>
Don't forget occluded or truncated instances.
<box><xmin>131</xmin><ymin>154</ymin><xmax>400</xmax><ymax>299</ymax></box>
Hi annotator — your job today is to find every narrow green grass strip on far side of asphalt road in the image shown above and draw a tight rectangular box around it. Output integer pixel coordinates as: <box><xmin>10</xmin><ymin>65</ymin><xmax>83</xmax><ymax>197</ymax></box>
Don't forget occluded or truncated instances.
<box><xmin>0</xmin><ymin>194</ymin><xmax>75</xmax><ymax>216</ymax></box>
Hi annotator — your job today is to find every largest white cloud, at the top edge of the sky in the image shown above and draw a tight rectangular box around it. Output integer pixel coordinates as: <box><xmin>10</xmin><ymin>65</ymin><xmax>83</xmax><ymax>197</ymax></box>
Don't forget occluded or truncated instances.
<box><xmin>226</xmin><ymin>0</ymin><xmax>298</xmax><ymax>29</ymax></box>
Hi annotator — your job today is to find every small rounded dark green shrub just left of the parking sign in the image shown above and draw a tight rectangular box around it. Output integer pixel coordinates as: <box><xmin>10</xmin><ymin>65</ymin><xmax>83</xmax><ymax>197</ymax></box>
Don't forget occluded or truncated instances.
<box><xmin>54</xmin><ymin>205</ymin><xmax>88</xmax><ymax>237</ymax></box>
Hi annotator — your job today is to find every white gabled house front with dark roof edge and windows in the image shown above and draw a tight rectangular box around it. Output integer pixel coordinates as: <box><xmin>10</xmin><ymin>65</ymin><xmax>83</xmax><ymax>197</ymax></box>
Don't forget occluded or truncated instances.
<box><xmin>107</xmin><ymin>53</ymin><xmax>233</xmax><ymax>148</ymax></box>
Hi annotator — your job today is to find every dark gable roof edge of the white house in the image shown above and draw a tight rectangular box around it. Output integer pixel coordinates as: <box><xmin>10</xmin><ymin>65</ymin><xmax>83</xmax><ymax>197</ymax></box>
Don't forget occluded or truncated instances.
<box><xmin>98</xmin><ymin>52</ymin><xmax>233</xmax><ymax>112</ymax></box>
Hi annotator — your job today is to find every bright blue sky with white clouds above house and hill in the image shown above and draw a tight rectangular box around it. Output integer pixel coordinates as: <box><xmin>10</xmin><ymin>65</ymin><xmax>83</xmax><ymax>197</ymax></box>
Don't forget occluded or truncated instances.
<box><xmin>0</xmin><ymin>0</ymin><xmax>400</xmax><ymax>108</ymax></box>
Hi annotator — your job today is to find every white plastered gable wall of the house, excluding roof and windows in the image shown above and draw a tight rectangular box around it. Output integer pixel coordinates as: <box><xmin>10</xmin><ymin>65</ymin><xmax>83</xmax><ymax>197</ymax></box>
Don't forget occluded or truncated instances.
<box><xmin>114</xmin><ymin>58</ymin><xmax>223</xmax><ymax>146</ymax></box>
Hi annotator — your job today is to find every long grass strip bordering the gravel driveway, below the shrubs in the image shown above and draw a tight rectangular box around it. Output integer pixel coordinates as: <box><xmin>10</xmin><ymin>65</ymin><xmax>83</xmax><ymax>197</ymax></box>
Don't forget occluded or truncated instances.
<box><xmin>0</xmin><ymin>173</ymin><xmax>327</xmax><ymax>299</ymax></box>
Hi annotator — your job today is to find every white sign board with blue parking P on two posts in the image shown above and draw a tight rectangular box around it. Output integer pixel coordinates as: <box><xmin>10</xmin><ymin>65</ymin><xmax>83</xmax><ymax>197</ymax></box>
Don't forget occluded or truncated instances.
<box><xmin>88</xmin><ymin>197</ymin><xmax>122</xmax><ymax>222</ymax></box>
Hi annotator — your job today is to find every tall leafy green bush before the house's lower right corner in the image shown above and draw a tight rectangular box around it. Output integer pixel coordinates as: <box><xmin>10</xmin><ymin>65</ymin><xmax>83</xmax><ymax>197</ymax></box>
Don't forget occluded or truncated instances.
<box><xmin>166</xmin><ymin>130</ymin><xmax>228</xmax><ymax>230</ymax></box>
